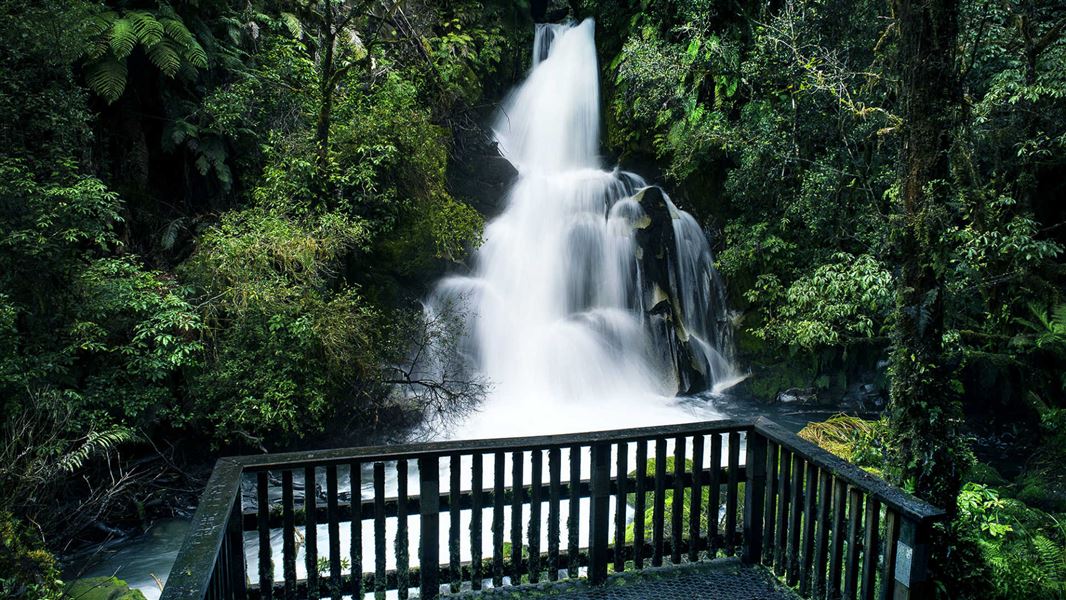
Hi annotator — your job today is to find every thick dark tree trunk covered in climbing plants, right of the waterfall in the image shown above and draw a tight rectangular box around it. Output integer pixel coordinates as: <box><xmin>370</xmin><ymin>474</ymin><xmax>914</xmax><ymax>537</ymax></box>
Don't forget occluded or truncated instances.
<box><xmin>890</xmin><ymin>0</ymin><xmax>968</xmax><ymax>513</ymax></box>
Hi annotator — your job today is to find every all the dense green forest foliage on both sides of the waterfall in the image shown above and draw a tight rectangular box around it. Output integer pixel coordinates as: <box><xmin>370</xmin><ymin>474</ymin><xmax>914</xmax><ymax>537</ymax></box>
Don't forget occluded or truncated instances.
<box><xmin>0</xmin><ymin>0</ymin><xmax>1066</xmax><ymax>598</ymax></box>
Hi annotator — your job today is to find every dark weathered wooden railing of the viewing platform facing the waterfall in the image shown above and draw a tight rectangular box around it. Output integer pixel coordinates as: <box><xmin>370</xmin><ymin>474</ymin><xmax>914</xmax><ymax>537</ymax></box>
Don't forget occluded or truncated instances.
<box><xmin>155</xmin><ymin>419</ymin><xmax>942</xmax><ymax>600</ymax></box>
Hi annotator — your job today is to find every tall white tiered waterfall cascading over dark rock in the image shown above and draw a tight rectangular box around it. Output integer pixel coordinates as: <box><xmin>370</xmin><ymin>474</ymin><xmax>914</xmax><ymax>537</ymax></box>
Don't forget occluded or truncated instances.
<box><xmin>425</xmin><ymin>20</ymin><xmax>736</xmax><ymax>437</ymax></box>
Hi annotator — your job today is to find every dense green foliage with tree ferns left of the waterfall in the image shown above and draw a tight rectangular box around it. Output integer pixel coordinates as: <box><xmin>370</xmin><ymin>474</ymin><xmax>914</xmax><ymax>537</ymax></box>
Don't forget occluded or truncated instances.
<box><xmin>0</xmin><ymin>0</ymin><xmax>530</xmax><ymax>597</ymax></box>
